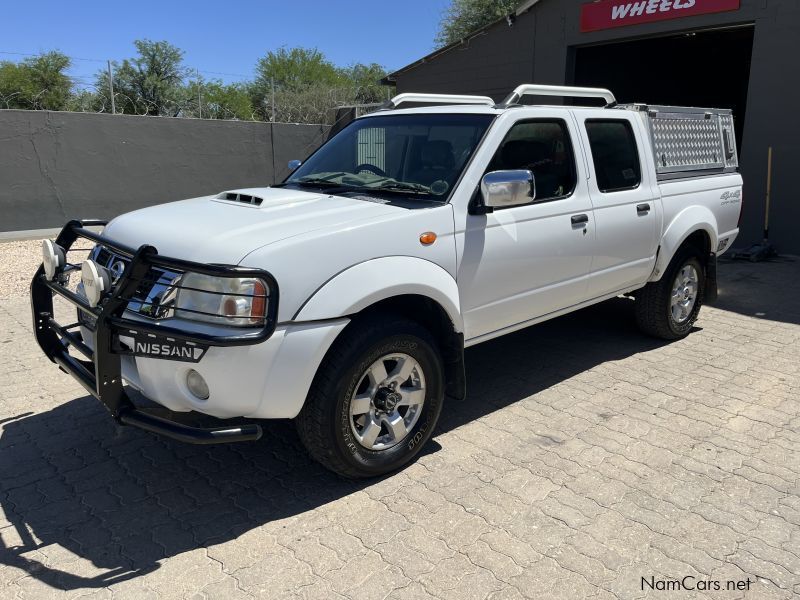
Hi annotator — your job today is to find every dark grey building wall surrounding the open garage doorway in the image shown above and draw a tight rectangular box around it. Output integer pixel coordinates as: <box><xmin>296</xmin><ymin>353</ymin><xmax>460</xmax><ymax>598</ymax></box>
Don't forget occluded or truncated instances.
<box><xmin>397</xmin><ymin>0</ymin><xmax>800</xmax><ymax>254</ymax></box>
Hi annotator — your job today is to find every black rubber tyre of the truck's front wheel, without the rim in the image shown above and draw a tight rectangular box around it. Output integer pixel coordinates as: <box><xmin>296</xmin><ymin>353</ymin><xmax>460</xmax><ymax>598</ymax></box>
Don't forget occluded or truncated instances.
<box><xmin>295</xmin><ymin>314</ymin><xmax>444</xmax><ymax>478</ymax></box>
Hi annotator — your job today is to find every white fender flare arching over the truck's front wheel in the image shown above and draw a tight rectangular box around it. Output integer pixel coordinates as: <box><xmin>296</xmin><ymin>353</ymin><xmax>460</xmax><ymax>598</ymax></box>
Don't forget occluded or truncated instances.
<box><xmin>292</xmin><ymin>256</ymin><xmax>464</xmax><ymax>333</ymax></box>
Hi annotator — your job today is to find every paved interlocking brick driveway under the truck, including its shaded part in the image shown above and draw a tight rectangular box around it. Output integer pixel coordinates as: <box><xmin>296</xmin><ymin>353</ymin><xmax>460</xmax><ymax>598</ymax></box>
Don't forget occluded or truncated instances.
<box><xmin>0</xmin><ymin>255</ymin><xmax>800</xmax><ymax>600</ymax></box>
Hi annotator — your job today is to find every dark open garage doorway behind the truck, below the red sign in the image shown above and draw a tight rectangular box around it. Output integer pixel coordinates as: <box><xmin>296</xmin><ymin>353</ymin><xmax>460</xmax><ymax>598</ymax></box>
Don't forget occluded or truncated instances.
<box><xmin>573</xmin><ymin>25</ymin><xmax>754</xmax><ymax>150</ymax></box>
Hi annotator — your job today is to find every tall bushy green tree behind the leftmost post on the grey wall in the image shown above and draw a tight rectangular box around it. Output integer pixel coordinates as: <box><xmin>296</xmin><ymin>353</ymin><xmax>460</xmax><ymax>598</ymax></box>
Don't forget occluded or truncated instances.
<box><xmin>96</xmin><ymin>40</ymin><xmax>190</xmax><ymax>117</ymax></box>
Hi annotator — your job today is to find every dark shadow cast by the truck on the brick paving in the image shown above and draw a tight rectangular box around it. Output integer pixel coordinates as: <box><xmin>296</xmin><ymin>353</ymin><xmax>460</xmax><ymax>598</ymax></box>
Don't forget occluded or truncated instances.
<box><xmin>0</xmin><ymin>299</ymin><xmax>680</xmax><ymax>590</ymax></box>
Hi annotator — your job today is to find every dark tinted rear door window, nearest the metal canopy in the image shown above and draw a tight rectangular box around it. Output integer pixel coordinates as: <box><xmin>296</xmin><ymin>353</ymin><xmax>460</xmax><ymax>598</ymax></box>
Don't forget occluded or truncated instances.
<box><xmin>586</xmin><ymin>119</ymin><xmax>642</xmax><ymax>192</ymax></box>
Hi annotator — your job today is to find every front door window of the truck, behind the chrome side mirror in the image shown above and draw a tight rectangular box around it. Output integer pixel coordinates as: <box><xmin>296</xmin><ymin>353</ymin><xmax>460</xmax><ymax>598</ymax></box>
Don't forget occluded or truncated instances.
<box><xmin>487</xmin><ymin>119</ymin><xmax>578</xmax><ymax>202</ymax></box>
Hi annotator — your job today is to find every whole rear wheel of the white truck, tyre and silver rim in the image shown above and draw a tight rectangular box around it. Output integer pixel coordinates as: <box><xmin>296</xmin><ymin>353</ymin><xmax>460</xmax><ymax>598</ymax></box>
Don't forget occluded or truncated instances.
<box><xmin>636</xmin><ymin>246</ymin><xmax>705</xmax><ymax>340</ymax></box>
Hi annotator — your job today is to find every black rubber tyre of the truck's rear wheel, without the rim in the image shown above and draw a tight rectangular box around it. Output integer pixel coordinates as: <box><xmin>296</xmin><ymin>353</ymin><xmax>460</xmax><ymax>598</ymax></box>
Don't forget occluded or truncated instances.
<box><xmin>635</xmin><ymin>245</ymin><xmax>706</xmax><ymax>340</ymax></box>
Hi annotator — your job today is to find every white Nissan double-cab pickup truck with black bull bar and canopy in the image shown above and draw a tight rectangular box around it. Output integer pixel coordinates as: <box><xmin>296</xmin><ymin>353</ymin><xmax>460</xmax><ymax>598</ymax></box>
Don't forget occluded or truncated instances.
<box><xmin>31</xmin><ymin>85</ymin><xmax>742</xmax><ymax>477</ymax></box>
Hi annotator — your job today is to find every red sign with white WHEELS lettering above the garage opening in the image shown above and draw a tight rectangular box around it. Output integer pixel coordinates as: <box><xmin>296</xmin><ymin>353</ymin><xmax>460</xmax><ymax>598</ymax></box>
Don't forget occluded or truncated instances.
<box><xmin>581</xmin><ymin>0</ymin><xmax>740</xmax><ymax>32</ymax></box>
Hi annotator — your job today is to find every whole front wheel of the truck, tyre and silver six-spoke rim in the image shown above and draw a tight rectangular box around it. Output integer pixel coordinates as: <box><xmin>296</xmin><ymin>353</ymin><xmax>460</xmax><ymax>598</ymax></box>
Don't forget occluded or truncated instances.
<box><xmin>296</xmin><ymin>315</ymin><xmax>444</xmax><ymax>478</ymax></box>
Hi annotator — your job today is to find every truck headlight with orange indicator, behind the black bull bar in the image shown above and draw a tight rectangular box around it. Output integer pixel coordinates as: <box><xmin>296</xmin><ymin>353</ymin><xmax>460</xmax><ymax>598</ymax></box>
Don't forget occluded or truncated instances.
<box><xmin>175</xmin><ymin>273</ymin><xmax>269</xmax><ymax>327</ymax></box>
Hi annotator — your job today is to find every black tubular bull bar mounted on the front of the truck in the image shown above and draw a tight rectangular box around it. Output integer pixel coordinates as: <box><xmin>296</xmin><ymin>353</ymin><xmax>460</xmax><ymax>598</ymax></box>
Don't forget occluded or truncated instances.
<box><xmin>31</xmin><ymin>220</ymin><xmax>278</xmax><ymax>444</ymax></box>
